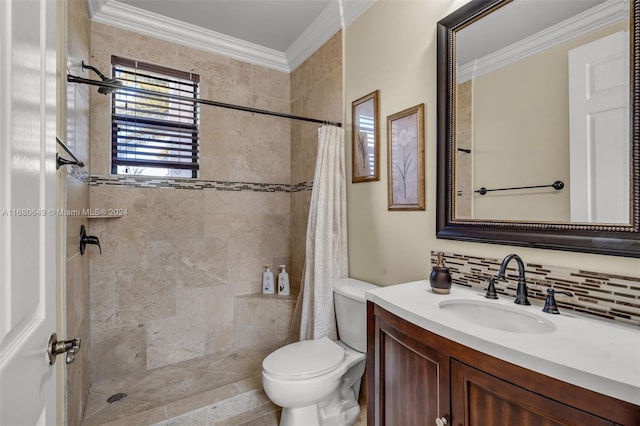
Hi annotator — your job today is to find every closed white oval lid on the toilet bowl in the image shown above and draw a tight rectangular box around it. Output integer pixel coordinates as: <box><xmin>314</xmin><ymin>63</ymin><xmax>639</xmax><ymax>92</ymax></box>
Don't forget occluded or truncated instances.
<box><xmin>262</xmin><ymin>337</ymin><xmax>345</xmax><ymax>379</ymax></box>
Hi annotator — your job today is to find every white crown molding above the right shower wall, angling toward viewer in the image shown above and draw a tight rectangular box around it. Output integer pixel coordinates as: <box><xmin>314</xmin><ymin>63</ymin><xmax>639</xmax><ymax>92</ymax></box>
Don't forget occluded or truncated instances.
<box><xmin>285</xmin><ymin>0</ymin><xmax>375</xmax><ymax>71</ymax></box>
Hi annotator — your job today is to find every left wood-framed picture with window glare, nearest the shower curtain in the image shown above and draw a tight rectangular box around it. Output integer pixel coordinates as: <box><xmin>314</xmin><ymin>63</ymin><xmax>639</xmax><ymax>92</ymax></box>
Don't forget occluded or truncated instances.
<box><xmin>351</xmin><ymin>90</ymin><xmax>380</xmax><ymax>183</ymax></box>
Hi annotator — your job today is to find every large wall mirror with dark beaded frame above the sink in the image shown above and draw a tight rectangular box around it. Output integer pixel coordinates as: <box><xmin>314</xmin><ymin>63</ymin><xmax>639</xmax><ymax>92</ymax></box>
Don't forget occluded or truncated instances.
<box><xmin>436</xmin><ymin>0</ymin><xmax>640</xmax><ymax>257</ymax></box>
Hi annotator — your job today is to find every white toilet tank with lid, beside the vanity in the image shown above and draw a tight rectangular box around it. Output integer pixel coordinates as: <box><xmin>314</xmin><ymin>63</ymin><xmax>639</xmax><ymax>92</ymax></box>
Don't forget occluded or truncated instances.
<box><xmin>333</xmin><ymin>278</ymin><xmax>378</xmax><ymax>353</ymax></box>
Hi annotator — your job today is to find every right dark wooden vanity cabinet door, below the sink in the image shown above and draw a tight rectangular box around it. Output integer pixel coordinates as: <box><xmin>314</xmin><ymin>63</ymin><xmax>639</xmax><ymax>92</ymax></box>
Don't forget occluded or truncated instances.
<box><xmin>451</xmin><ymin>360</ymin><xmax>614</xmax><ymax>426</ymax></box>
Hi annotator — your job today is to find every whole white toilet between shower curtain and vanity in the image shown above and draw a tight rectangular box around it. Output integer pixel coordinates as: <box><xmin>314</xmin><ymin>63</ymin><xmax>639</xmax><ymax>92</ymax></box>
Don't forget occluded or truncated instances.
<box><xmin>262</xmin><ymin>278</ymin><xmax>378</xmax><ymax>426</ymax></box>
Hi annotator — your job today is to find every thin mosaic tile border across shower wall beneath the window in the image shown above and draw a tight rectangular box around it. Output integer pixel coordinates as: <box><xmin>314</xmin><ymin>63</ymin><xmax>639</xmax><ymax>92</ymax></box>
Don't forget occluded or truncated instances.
<box><xmin>90</xmin><ymin>175</ymin><xmax>313</xmax><ymax>192</ymax></box>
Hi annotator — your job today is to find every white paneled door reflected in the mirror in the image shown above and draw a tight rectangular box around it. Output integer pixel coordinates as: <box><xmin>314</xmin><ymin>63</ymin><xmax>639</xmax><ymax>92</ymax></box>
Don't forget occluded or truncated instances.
<box><xmin>569</xmin><ymin>31</ymin><xmax>630</xmax><ymax>224</ymax></box>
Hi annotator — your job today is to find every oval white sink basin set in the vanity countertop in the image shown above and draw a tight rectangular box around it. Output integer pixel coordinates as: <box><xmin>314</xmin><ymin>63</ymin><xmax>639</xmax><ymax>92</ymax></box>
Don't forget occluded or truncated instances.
<box><xmin>438</xmin><ymin>299</ymin><xmax>557</xmax><ymax>334</ymax></box>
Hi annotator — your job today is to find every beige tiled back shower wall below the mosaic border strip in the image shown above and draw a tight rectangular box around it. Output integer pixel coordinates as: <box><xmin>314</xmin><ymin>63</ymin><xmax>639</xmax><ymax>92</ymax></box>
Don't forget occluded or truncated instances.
<box><xmin>91</xmin><ymin>185</ymin><xmax>290</xmax><ymax>379</ymax></box>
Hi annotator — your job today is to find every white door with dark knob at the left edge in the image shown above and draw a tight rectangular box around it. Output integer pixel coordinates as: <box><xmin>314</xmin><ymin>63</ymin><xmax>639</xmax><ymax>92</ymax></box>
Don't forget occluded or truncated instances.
<box><xmin>0</xmin><ymin>0</ymin><xmax>56</xmax><ymax>426</ymax></box>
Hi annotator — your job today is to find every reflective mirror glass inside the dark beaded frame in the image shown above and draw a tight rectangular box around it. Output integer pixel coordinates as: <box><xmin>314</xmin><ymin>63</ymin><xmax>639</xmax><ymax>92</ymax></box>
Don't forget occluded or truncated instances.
<box><xmin>454</xmin><ymin>0</ymin><xmax>630</xmax><ymax>224</ymax></box>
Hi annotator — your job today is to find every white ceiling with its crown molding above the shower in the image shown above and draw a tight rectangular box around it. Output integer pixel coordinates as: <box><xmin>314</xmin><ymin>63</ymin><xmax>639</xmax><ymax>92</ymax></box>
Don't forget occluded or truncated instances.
<box><xmin>87</xmin><ymin>0</ymin><xmax>374</xmax><ymax>72</ymax></box>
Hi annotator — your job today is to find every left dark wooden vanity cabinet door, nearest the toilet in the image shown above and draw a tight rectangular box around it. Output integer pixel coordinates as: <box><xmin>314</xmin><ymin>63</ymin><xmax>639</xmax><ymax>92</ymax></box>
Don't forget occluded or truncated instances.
<box><xmin>367</xmin><ymin>302</ymin><xmax>450</xmax><ymax>426</ymax></box>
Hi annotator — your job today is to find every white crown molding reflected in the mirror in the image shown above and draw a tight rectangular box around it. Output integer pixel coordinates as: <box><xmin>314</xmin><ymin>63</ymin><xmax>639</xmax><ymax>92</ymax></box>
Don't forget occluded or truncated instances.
<box><xmin>456</xmin><ymin>0</ymin><xmax>629</xmax><ymax>83</ymax></box>
